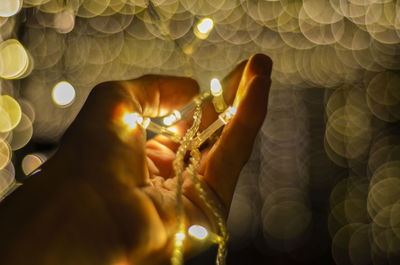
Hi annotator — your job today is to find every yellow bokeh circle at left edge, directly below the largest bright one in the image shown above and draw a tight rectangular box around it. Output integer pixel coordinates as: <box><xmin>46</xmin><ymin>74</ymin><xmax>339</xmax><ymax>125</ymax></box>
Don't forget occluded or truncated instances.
<box><xmin>0</xmin><ymin>95</ymin><xmax>22</xmax><ymax>132</ymax></box>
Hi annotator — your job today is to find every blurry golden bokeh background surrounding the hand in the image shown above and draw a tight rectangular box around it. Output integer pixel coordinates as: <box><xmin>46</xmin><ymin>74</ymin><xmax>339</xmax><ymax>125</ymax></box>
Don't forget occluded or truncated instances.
<box><xmin>0</xmin><ymin>0</ymin><xmax>400</xmax><ymax>265</ymax></box>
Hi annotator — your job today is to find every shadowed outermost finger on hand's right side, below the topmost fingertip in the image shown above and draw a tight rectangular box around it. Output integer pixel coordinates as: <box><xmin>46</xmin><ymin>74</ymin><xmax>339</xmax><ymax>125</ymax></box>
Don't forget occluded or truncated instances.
<box><xmin>204</xmin><ymin>60</ymin><xmax>271</xmax><ymax>209</ymax></box>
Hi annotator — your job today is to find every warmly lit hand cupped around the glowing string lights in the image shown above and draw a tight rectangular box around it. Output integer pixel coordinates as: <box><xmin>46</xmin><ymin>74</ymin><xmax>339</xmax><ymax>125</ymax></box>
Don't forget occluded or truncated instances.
<box><xmin>0</xmin><ymin>54</ymin><xmax>272</xmax><ymax>265</ymax></box>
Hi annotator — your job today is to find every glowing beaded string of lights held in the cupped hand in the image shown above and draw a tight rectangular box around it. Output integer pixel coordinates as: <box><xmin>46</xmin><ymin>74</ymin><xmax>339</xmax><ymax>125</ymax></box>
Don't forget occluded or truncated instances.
<box><xmin>122</xmin><ymin>78</ymin><xmax>236</xmax><ymax>265</ymax></box>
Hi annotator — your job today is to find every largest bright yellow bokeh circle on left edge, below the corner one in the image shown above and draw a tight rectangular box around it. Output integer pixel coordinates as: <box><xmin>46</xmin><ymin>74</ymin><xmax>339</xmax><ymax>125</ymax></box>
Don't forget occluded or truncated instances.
<box><xmin>0</xmin><ymin>39</ymin><xmax>29</xmax><ymax>79</ymax></box>
